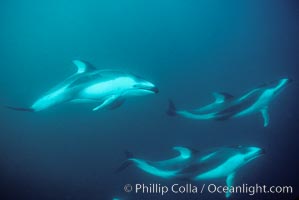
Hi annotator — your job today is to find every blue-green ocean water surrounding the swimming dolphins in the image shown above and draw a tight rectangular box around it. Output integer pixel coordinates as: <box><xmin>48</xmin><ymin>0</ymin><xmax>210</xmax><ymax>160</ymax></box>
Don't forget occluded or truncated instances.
<box><xmin>0</xmin><ymin>0</ymin><xmax>299</xmax><ymax>200</ymax></box>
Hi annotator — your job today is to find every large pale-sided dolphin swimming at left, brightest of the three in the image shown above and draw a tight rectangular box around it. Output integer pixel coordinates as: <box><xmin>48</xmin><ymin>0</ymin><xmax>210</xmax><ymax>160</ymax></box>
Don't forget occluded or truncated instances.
<box><xmin>7</xmin><ymin>60</ymin><xmax>158</xmax><ymax>112</ymax></box>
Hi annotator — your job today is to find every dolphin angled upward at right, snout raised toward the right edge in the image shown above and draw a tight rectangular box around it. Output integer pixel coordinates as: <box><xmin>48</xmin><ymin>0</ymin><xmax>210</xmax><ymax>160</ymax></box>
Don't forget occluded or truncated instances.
<box><xmin>167</xmin><ymin>78</ymin><xmax>292</xmax><ymax>127</ymax></box>
